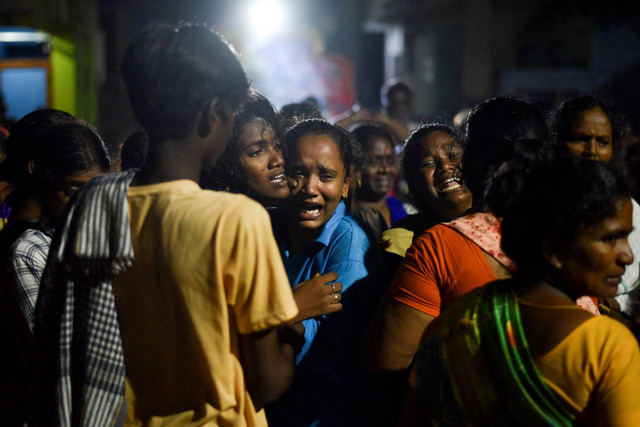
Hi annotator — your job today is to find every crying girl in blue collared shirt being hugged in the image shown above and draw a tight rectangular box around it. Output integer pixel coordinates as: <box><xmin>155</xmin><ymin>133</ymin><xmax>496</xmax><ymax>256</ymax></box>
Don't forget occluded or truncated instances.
<box><xmin>267</xmin><ymin>119</ymin><xmax>386</xmax><ymax>426</ymax></box>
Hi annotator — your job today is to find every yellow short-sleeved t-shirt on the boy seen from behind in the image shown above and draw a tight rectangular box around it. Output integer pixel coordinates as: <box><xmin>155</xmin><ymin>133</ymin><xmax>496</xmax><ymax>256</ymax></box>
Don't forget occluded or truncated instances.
<box><xmin>113</xmin><ymin>180</ymin><xmax>298</xmax><ymax>426</ymax></box>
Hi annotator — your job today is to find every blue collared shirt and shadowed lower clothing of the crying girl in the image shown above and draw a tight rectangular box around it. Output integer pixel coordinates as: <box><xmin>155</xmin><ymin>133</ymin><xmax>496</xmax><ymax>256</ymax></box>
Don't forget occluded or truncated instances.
<box><xmin>267</xmin><ymin>202</ymin><xmax>386</xmax><ymax>427</ymax></box>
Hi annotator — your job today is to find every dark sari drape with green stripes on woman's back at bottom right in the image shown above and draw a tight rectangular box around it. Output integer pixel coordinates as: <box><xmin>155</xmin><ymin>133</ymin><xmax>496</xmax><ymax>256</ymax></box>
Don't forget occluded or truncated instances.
<box><xmin>415</xmin><ymin>281</ymin><xmax>573</xmax><ymax>426</ymax></box>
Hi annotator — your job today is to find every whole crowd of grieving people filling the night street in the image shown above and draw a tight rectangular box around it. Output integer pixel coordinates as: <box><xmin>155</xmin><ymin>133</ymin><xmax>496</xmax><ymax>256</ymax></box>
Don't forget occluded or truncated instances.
<box><xmin>0</xmin><ymin>23</ymin><xmax>640</xmax><ymax>427</ymax></box>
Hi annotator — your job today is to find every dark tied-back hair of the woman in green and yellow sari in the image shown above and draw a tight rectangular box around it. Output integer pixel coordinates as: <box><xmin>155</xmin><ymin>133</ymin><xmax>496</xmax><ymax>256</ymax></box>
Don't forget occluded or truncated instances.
<box><xmin>496</xmin><ymin>155</ymin><xmax>631</xmax><ymax>275</ymax></box>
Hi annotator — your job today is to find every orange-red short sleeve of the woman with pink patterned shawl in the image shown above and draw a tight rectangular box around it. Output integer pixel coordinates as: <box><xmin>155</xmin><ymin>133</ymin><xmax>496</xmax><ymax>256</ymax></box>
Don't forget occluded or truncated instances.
<box><xmin>389</xmin><ymin>224</ymin><xmax>496</xmax><ymax>317</ymax></box>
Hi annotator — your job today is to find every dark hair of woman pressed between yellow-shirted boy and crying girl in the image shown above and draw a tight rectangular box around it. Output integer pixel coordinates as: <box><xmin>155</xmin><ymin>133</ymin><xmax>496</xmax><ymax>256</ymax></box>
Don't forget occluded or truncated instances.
<box><xmin>202</xmin><ymin>90</ymin><xmax>281</xmax><ymax>195</ymax></box>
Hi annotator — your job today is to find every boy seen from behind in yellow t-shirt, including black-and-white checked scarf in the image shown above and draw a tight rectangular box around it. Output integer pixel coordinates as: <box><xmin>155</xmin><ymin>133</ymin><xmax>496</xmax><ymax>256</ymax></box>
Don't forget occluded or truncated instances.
<box><xmin>32</xmin><ymin>23</ymin><xmax>302</xmax><ymax>426</ymax></box>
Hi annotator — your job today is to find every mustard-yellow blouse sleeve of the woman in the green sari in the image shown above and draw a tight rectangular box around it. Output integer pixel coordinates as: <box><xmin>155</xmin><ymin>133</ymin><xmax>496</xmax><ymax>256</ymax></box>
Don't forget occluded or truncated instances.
<box><xmin>535</xmin><ymin>316</ymin><xmax>640</xmax><ymax>426</ymax></box>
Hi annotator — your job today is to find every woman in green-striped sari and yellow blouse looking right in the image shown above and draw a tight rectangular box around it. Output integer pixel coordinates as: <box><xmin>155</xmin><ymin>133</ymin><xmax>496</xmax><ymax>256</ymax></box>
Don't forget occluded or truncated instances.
<box><xmin>410</xmin><ymin>157</ymin><xmax>640</xmax><ymax>426</ymax></box>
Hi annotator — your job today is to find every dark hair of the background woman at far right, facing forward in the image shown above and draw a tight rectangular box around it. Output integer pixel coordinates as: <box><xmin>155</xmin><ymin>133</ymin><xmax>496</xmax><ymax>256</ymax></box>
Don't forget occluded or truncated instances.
<box><xmin>549</xmin><ymin>95</ymin><xmax>625</xmax><ymax>152</ymax></box>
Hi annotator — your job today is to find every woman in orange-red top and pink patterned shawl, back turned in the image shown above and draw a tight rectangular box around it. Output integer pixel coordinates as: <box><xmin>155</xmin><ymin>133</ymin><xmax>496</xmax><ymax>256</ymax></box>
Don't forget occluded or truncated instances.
<box><xmin>366</xmin><ymin>97</ymin><xmax>548</xmax><ymax>374</ymax></box>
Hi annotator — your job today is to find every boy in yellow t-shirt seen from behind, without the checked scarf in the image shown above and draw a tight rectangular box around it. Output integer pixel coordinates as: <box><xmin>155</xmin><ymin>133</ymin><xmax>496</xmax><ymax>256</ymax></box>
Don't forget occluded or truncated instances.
<box><xmin>114</xmin><ymin>26</ymin><xmax>297</xmax><ymax>425</ymax></box>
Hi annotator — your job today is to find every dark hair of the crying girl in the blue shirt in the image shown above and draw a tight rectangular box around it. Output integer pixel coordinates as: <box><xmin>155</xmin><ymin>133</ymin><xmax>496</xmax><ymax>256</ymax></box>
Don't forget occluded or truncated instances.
<box><xmin>284</xmin><ymin>119</ymin><xmax>362</xmax><ymax>178</ymax></box>
